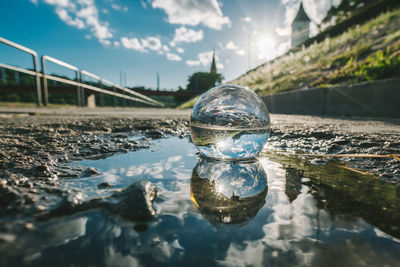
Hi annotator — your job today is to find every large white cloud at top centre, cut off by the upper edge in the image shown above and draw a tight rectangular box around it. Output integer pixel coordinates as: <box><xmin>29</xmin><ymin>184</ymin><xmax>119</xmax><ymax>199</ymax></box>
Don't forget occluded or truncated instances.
<box><xmin>152</xmin><ymin>0</ymin><xmax>231</xmax><ymax>30</ymax></box>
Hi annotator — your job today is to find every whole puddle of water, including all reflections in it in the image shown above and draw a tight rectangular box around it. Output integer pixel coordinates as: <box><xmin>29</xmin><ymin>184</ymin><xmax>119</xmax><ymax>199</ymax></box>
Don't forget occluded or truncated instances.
<box><xmin>0</xmin><ymin>137</ymin><xmax>400</xmax><ymax>266</ymax></box>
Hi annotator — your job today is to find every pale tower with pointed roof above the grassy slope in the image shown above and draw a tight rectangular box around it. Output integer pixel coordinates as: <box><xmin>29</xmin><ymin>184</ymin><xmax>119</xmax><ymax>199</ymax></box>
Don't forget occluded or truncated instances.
<box><xmin>291</xmin><ymin>2</ymin><xmax>311</xmax><ymax>47</ymax></box>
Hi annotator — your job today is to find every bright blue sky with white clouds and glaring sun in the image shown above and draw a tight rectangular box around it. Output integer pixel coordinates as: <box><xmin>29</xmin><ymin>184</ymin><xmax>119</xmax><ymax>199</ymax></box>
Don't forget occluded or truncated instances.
<box><xmin>0</xmin><ymin>0</ymin><xmax>339</xmax><ymax>90</ymax></box>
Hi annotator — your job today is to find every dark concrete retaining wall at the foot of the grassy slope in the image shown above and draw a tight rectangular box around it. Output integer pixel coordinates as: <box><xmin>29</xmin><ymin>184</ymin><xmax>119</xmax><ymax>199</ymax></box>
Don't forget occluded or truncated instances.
<box><xmin>262</xmin><ymin>78</ymin><xmax>400</xmax><ymax>118</ymax></box>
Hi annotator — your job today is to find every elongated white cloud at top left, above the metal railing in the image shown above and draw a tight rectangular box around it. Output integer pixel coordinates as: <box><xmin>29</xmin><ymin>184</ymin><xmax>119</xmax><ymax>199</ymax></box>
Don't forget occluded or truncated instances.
<box><xmin>44</xmin><ymin>0</ymin><xmax>113</xmax><ymax>45</ymax></box>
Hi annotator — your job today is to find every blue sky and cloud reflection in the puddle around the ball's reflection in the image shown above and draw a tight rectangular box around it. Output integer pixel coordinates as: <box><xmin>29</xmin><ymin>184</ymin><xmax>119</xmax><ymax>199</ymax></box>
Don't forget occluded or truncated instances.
<box><xmin>5</xmin><ymin>137</ymin><xmax>400</xmax><ymax>266</ymax></box>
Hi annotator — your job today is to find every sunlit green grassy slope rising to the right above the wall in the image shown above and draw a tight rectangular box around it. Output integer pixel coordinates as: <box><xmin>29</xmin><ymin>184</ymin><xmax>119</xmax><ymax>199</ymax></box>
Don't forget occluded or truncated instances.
<box><xmin>179</xmin><ymin>9</ymin><xmax>400</xmax><ymax>108</ymax></box>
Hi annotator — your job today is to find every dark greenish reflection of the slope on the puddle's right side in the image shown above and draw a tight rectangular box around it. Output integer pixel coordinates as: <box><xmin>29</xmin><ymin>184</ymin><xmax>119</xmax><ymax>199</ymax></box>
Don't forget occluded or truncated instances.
<box><xmin>268</xmin><ymin>155</ymin><xmax>400</xmax><ymax>238</ymax></box>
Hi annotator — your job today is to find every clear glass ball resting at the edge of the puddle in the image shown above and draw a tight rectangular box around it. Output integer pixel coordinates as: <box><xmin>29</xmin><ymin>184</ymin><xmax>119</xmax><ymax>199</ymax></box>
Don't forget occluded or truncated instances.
<box><xmin>190</xmin><ymin>85</ymin><xmax>270</xmax><ymax>159</ymax></box>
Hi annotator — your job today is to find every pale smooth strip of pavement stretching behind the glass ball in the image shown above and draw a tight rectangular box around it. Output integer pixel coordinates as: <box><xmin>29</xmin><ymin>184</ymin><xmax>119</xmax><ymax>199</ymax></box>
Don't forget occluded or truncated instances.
<box><xmin>0</xmin><ymin>107</ymin><xmax>400</xmax><ymax>134</ymax></box>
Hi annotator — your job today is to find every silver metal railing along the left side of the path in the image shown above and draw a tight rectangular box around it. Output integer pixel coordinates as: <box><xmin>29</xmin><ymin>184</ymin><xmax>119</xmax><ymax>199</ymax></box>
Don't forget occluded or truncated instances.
<box><xmin>0</xmin><ymin>37</ymin><xmax>164</xmax><ymax>106</ymax></box>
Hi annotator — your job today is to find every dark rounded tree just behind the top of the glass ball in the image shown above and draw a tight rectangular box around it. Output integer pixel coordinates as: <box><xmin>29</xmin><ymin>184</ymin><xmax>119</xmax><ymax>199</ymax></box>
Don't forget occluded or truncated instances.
<box><xmin>186</xmin><ymin>72</ymin><xmax>224</xmax><ymax>93</ymax></box>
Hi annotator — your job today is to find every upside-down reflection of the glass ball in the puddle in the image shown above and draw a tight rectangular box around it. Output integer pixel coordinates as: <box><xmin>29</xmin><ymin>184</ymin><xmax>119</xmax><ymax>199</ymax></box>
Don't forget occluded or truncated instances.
<box><xmin>190</xmin><ymin>158</ymin><xmax>268</xmax><ymax>227</ymax></box>
